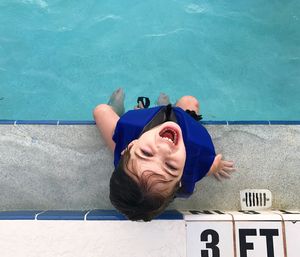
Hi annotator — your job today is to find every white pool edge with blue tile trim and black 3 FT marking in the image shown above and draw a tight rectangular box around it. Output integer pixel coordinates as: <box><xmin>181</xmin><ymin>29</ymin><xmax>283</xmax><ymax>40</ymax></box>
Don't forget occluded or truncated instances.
<box><xmin>0</xmin><ymin>210</ymin><xmax>300</xmax><ymax>257</ymax></box>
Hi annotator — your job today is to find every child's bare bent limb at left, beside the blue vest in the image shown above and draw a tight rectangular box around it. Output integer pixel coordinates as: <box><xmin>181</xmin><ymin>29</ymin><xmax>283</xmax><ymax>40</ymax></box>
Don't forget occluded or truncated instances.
<box><xmin>93</xmin><ymin>104</ymin><xmax>120</xmax><ymax>151</ymax></box>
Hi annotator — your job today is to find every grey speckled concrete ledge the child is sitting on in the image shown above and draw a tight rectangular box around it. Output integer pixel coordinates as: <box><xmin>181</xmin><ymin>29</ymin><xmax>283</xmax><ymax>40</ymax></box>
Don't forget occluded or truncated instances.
<box><xmin>0</xmin><ymin>125</ymin><xmax>300</xmax><ymax>210</ymax></box>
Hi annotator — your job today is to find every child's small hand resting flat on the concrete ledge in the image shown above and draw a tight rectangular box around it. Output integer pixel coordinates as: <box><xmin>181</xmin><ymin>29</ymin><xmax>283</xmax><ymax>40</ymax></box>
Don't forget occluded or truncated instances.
<box><xmin>207</xmin><ymin>154</ymin><xmax>235</xmax><ymax>180</ymax></box>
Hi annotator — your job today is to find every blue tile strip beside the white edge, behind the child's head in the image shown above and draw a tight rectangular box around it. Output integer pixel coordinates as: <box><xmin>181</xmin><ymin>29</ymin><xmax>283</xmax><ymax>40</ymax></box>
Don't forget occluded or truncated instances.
<box><xmin>0</xmin><ymin>210</ymin><xmax>183</xmax><ymax>221</ymax></box>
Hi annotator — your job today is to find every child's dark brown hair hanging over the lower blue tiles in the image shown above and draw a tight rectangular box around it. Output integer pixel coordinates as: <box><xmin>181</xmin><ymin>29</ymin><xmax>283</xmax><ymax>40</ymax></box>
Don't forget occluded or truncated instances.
<box><xmin>109</xmin><ymin>149</ymin><xmax>179</xmax><ymax>221</ymax></box>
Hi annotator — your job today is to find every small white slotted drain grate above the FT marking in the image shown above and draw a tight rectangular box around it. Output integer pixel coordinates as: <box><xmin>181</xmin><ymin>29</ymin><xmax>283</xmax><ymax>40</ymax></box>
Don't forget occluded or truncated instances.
<box><xmin>240</xmin><ymin>189</ymin><xmax>272</xmax><ymax>210</ymax></box>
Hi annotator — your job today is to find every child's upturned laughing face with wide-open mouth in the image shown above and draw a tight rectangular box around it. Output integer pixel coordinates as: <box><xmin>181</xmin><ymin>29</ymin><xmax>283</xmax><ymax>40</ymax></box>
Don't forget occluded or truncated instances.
<box><xmin>122</xmin><ymin>122</ymin><xmax>186</xmax><ymax>193</ymax></box>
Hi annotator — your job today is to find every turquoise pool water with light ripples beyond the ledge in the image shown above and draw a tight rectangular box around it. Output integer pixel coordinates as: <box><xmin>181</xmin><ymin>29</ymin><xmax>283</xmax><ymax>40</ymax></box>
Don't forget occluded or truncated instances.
<box><xmin>0</xmin><ymin>0</ymin><xmax>300</xmax><ymax>120</ymax></box>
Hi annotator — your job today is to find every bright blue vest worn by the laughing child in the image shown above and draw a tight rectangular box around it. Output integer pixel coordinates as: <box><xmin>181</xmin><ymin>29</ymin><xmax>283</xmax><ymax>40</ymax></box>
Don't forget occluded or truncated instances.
<box><xmin>113</xmin><ymin>106</ymin><xmax>216</xmax><ymax>197</ymax></box>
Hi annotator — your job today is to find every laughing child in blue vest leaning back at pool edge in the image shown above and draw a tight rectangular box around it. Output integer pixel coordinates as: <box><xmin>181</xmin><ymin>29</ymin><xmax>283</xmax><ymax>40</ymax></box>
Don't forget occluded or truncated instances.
<box><xmin>94</xmin><ymin>89</ymin><xmax>234</xmax><ymax>221</ymax></box>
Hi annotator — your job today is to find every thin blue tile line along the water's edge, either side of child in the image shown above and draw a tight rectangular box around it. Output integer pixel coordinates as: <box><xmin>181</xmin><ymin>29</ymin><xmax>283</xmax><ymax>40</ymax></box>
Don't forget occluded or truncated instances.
<box><xmin>0</xmin><ymin>120</ymin><xmax>300</xmax><ymax>125</ymax></box>
